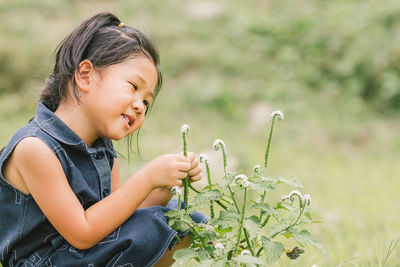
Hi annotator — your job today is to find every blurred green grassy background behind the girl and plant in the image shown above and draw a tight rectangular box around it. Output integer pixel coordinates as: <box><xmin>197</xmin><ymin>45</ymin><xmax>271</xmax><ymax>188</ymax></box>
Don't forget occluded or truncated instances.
<box><xmin>0</xmin><ymin>0</ymin><xmax>400</xmax><ymax>266</ymax></box>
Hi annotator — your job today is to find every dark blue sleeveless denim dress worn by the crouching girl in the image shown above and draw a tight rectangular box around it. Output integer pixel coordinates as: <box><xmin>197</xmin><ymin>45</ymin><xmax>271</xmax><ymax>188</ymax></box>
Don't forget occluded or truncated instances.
<box><xmin>0</xmin><ymin>102</ymin><xmax>208</xmax><ymax>267</ymax></box>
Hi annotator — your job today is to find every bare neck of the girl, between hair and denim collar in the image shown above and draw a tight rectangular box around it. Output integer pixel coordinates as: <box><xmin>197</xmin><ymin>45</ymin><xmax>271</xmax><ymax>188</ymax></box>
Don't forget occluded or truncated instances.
<box><xmin>54</xmin><ymin>103</ymin><xmax>99</xmax><ymax>146</ymax></box>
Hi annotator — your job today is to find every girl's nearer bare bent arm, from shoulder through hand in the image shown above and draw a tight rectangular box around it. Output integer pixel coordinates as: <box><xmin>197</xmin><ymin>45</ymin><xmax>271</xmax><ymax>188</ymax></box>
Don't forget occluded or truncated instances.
<box><xmin>14</xmin><ymin>137</ymin><xmax>190</xmax><ymax>249</ymax></box>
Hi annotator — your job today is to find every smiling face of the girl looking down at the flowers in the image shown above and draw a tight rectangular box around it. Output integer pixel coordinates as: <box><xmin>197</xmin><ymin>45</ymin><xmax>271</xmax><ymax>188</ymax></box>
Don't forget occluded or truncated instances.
<box><xmin>84</xmin><ymin>56</ymin><xmax>158</xmax><ymax>140</ymax></box>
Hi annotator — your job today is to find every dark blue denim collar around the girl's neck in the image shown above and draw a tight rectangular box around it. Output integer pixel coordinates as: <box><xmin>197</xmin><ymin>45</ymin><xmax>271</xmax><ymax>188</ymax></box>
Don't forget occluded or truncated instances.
<box><xmin>34</xmin><ymin>102</ymin><xmax>117</xmax><ymax>157</ymax></box>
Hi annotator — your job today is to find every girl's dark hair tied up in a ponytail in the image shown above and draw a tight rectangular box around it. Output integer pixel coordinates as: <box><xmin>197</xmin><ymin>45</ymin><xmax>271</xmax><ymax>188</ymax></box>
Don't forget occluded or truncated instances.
<box><xmin>40</xmin><ymin>13</ymin><xmax>162</xmax><ymax>112</ymax></box>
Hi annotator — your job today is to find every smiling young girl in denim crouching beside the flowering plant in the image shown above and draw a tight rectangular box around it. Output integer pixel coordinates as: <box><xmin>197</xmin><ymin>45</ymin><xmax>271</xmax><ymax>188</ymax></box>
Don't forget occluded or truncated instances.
<box><xmin>0</xmin><ymin>13</ymin><xmax>208</xmax><ymax>267</ymax></box>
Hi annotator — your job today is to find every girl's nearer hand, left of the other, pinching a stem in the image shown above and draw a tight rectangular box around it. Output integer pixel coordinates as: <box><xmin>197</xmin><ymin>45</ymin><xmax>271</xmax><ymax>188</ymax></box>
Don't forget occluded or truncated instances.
<box><xmin>141</xmin><ymin>154</ymin><xmax>191</xmax><ymax>188</ymax></box>
